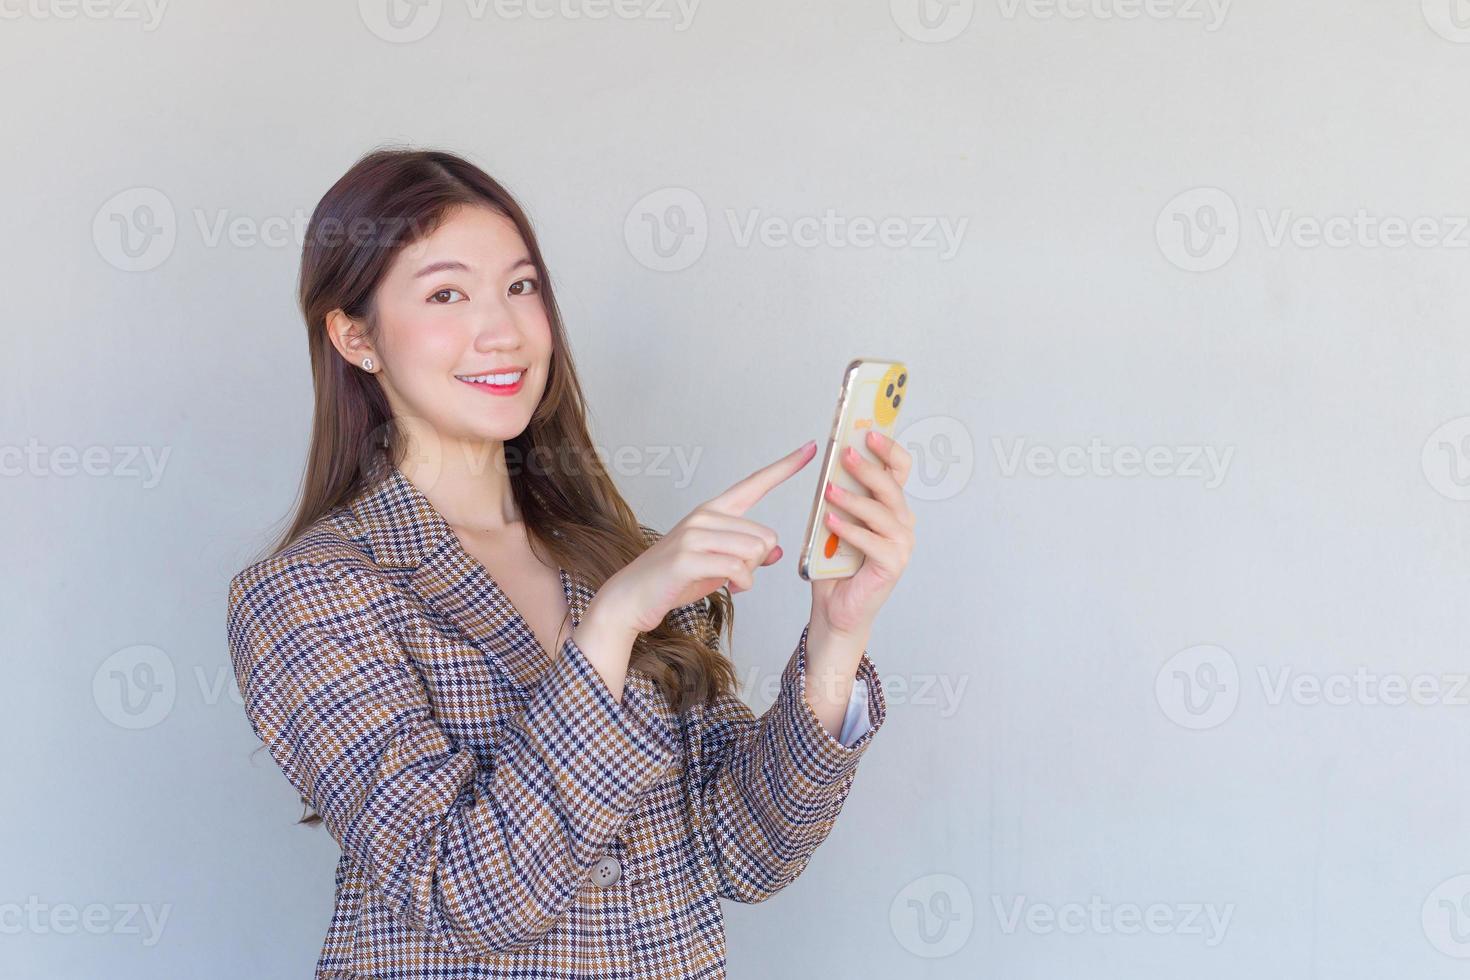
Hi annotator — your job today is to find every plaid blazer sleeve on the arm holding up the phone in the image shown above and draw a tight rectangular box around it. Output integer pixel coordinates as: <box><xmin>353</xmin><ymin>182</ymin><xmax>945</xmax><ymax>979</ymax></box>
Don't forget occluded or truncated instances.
<box><xmin>678</xmin><ymin>601</ymin><xmax>888</xmax><ymax>902</ymax></box>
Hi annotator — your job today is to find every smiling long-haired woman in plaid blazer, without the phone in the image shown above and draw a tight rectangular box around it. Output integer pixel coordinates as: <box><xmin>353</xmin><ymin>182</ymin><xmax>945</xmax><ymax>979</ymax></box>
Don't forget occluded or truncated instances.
<box><xmin>228</xmin><ymin>150</ymin><xmax>914</xmax><ymax>979</ymax></box>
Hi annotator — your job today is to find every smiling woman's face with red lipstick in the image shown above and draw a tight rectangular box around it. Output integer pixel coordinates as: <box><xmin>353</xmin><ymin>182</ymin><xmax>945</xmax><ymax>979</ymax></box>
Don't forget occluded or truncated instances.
<box><xmin>357</xmin><ymin>206</ymin><xmax>551</xmax><ymax>448</ymax></box>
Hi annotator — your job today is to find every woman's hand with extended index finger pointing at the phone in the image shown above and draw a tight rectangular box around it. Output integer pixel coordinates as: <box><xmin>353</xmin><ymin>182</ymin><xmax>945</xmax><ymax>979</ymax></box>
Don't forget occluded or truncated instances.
<box><xmin>592</xmin><ymin>441</ymin><xmax>816</xmax><ymax>633</ymax></box>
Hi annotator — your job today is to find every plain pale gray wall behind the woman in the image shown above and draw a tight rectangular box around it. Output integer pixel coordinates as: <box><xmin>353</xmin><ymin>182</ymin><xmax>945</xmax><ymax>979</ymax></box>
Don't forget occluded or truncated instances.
<box><xmin>0</xmin><ymin>0</ymin><xmax>1470</xmax><ymax>980</ymax></box>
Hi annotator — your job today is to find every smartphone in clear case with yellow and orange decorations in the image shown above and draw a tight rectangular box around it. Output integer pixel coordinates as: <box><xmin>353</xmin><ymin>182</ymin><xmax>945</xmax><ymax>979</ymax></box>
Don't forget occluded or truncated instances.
<box><xmin>797</xmin><ymin>357</ymin><xmax>908</xmax><ymax>582</ymax></box>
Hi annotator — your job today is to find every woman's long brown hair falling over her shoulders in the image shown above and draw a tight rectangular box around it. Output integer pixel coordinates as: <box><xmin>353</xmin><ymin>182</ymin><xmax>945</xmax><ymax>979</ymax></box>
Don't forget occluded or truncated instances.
<box><xmin>252</xmin><ymin>147</ymin><xmax>735</xmax><ymax>823</ymax></box>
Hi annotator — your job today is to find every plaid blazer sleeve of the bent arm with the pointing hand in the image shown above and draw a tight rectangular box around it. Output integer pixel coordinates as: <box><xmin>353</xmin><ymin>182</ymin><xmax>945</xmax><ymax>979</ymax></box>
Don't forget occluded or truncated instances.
<box><xmin>228</xmin><ymin>561</ymin><xmax>681</xmax><ymax>955</ymax></box>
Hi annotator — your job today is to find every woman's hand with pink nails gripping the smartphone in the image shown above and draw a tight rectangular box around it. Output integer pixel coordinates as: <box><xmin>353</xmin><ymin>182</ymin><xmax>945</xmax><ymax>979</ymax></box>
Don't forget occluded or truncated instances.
<box><xmin>811</xmin><ymin>429</ymin><xmax>914</xmax><ymax>642</ymax></box>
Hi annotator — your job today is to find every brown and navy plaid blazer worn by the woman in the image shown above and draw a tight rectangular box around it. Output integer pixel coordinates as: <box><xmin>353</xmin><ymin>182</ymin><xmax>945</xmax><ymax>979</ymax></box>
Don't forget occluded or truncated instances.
<box><xmin>219</xmin><ymin>466</ymin><xmax>886</xmax><ymax>980</ymax></box>
